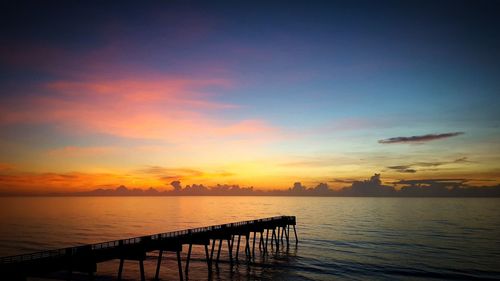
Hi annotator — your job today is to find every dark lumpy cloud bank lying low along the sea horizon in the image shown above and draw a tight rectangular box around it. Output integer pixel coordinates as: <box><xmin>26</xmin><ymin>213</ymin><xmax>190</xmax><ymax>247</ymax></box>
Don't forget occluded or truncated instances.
<box><xmin>49</xmin><ymin>174</ymin><xmax>500</xmax><ymax>197</ymax></box>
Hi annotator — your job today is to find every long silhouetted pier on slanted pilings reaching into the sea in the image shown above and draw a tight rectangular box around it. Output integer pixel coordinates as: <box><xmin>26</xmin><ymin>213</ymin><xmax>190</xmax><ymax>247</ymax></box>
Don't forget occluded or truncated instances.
<box><xmin>0</xmin><ymin>216</ymin><xmax>298</xmax><ymax>281</ymax></box>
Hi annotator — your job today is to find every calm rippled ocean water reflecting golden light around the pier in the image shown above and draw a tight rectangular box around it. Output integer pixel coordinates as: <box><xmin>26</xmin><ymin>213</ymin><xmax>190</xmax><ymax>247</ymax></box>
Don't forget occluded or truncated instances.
<box><xmin>0</xmin><ymin>197</ymin><xmax>500</xmax><ymax>280</ymax></box>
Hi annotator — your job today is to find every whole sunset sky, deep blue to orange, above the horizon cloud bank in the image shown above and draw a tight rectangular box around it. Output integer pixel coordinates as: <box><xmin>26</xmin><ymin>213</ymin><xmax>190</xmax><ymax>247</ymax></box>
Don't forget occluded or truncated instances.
<box><xmin>0</xmin><ymin>1</ymin><xmax>500</xmax><ymax>193</ymax></box>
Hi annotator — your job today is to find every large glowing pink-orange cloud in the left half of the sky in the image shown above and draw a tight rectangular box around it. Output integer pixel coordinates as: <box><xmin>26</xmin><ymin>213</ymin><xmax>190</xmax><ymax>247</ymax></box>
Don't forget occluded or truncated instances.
<box><xmin>0</xmin><ymin>74</ymin><xmax>279</xmax><ymax>144</ymax></box>
